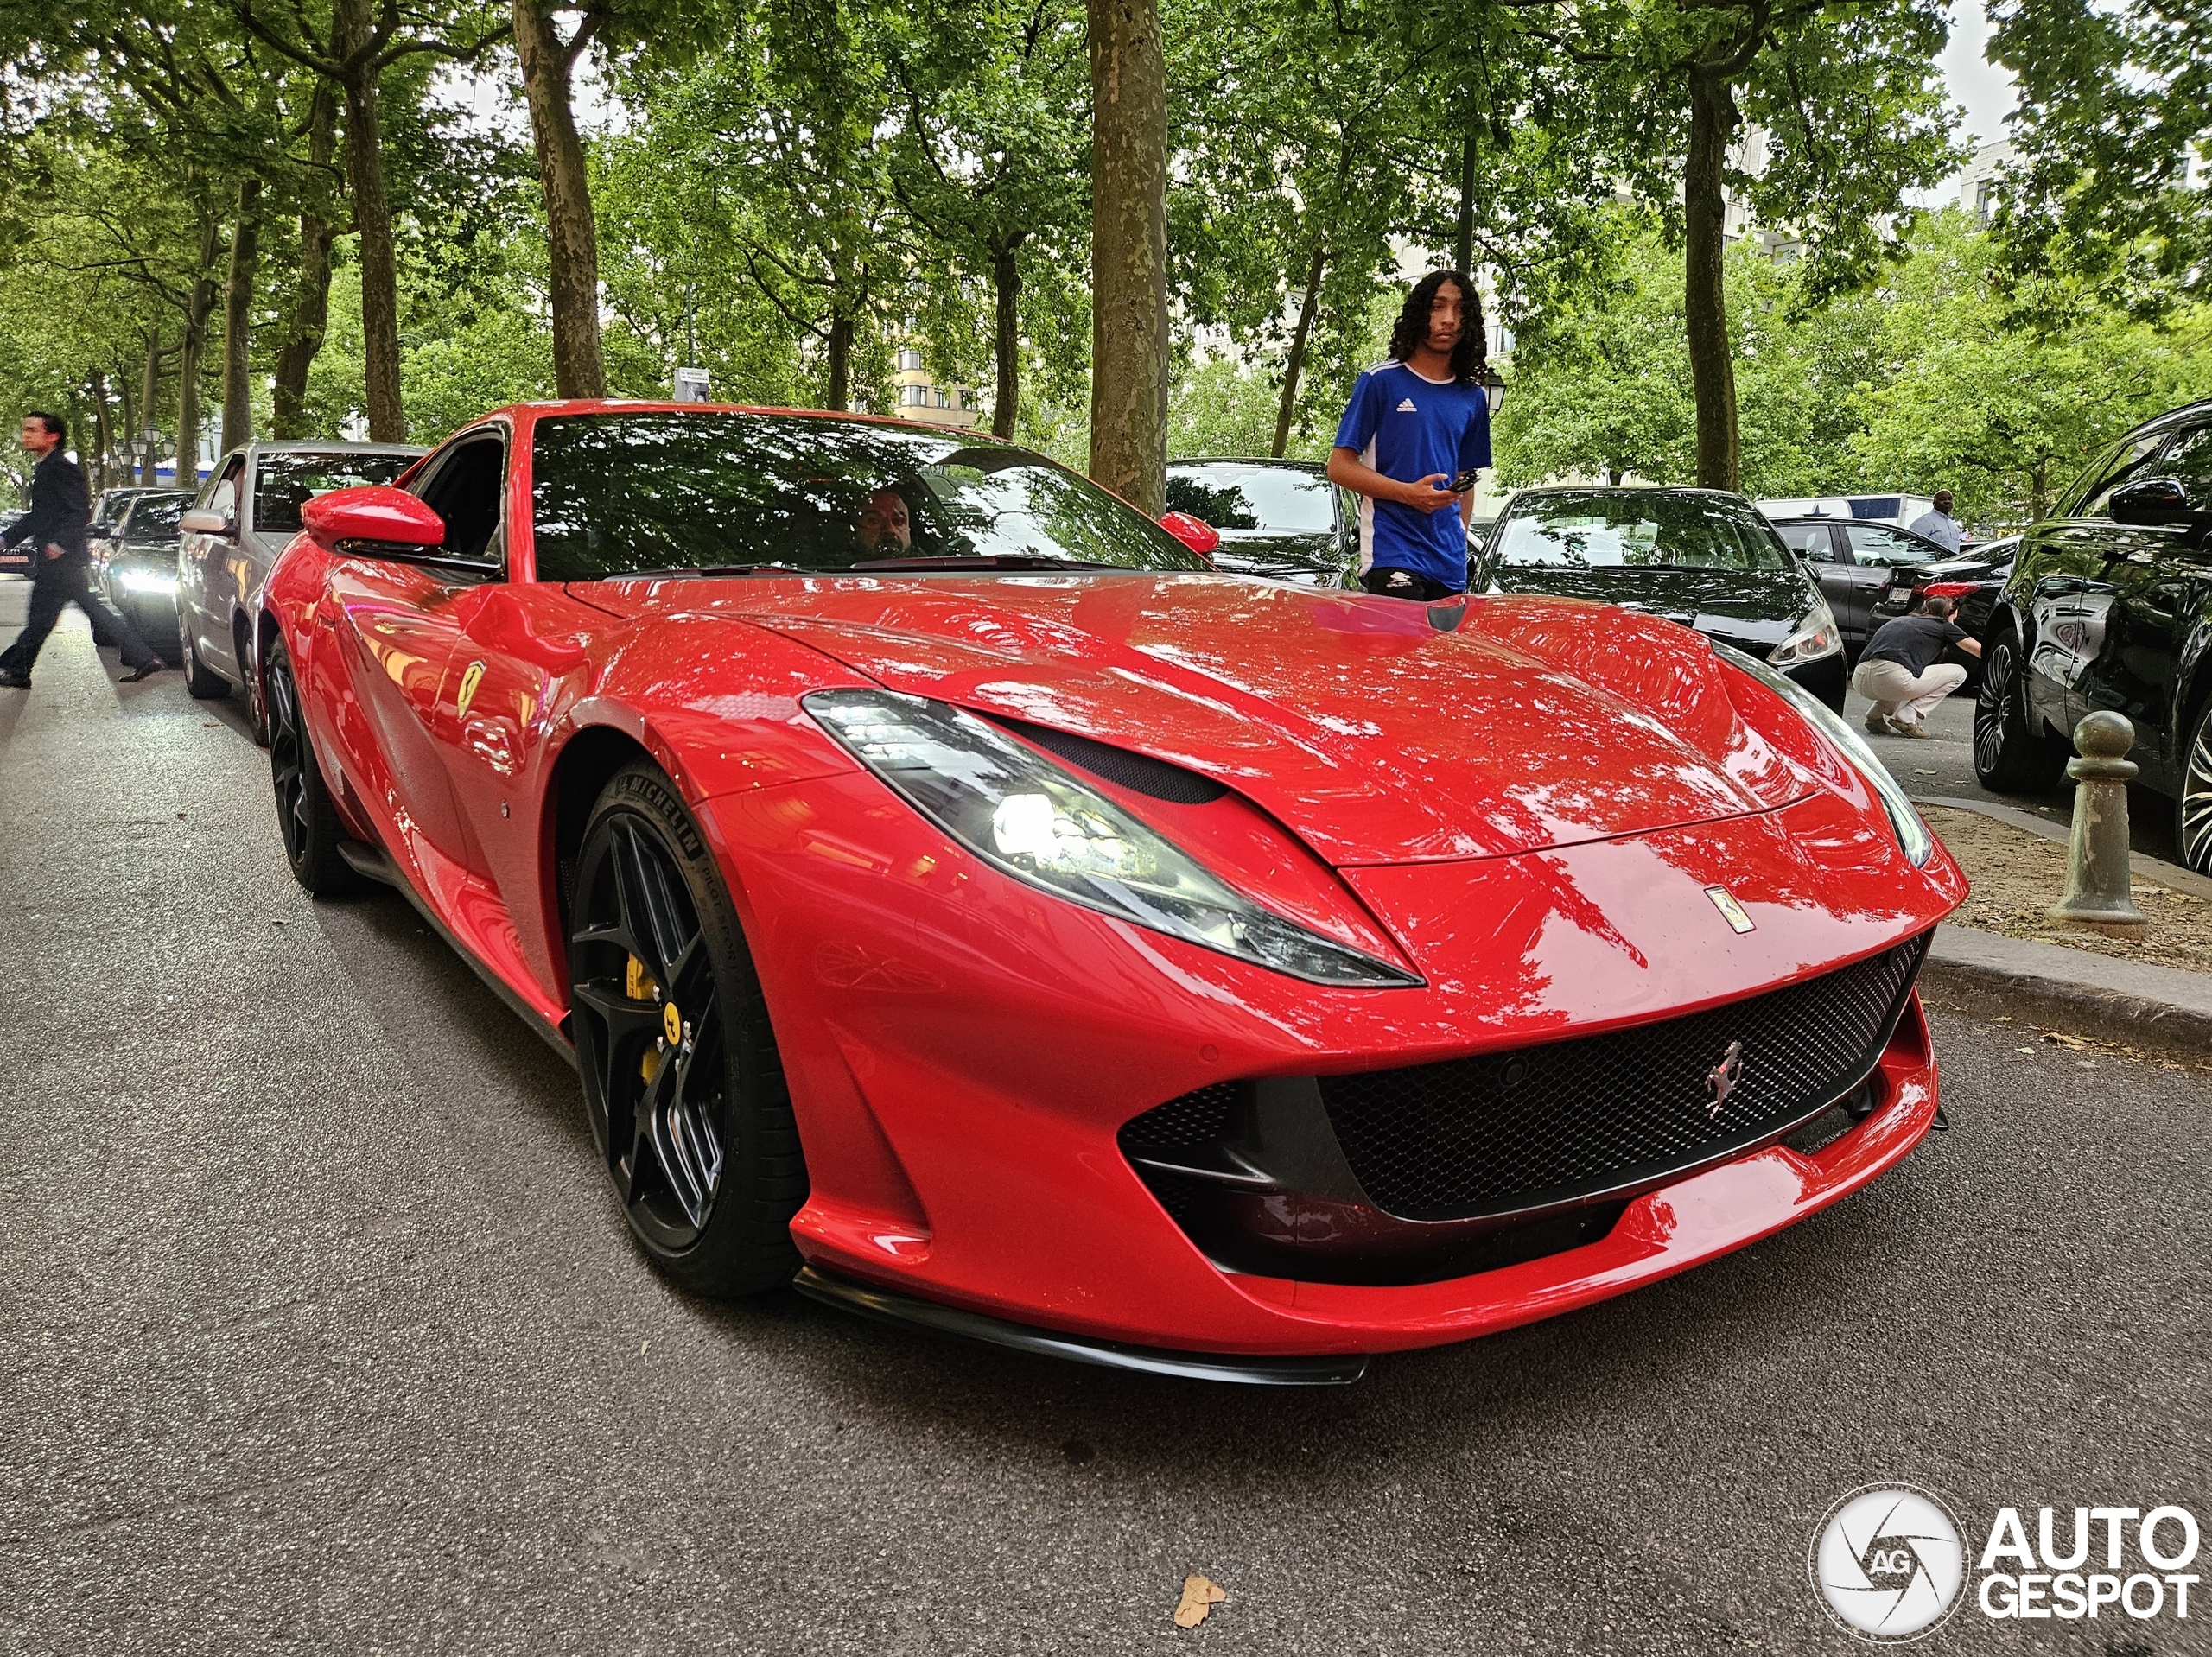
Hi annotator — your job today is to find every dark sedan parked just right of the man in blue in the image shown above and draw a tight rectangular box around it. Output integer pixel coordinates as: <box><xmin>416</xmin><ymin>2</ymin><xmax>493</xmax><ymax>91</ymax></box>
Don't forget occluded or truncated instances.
<box><xmin>1471</xmin><ymin>489</ymin><xmax>1845</xmax><ymax>710</ymax></box>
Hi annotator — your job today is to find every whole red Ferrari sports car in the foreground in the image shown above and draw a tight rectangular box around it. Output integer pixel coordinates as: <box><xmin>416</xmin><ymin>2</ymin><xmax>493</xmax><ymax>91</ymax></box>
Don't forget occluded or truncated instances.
<box><xmin>257</xmin><ymin>403</ymin><xmax>1964</xmax><ymax>1382</ymax></box>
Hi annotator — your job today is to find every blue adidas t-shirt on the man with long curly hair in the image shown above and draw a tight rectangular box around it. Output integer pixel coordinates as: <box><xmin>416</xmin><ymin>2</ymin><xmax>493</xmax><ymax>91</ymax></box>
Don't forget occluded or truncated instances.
<box><xmin>1336</xmin><ymin>363</ymin><xmax>1491</xmax><ymax>588</ymax></box>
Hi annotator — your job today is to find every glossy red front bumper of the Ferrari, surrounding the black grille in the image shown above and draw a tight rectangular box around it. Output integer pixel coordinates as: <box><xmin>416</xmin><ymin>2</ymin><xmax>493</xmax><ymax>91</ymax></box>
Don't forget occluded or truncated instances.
<box><xmin>695</xmin><ymin>774</ymin><xmax>1964</xmax><ymax>1358</ymax></box>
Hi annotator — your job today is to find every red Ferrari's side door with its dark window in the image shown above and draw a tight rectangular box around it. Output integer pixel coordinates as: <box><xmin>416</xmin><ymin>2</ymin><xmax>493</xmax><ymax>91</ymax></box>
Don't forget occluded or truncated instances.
<box><xmin>316</xmin><ymin>425</ymin><xmax>506</xmax><ymax>898</ymax></box>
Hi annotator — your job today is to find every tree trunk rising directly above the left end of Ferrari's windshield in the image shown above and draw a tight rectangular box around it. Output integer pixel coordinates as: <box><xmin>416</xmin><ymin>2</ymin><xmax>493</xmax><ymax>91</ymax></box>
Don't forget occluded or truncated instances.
<box><xmin>513</xmin><ymin>0</ymin><xmax>606</xmax><ymax>396</ymax></box>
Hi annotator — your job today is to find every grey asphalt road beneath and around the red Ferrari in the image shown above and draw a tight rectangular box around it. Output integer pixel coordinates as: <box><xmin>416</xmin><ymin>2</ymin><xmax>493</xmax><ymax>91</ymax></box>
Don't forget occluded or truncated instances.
<box><xmin>0</xmin><ymin>584</ymin><xmax>2212</xmax><ymax>1657</ymax></box>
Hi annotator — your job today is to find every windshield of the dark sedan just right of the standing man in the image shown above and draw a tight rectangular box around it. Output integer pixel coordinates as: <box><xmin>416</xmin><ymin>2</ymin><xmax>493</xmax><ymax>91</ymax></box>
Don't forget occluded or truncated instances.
<box><xmin>1496</xmin><ymin>489</ymin><xmax>1792</xmax><ymax>568</ymax></box>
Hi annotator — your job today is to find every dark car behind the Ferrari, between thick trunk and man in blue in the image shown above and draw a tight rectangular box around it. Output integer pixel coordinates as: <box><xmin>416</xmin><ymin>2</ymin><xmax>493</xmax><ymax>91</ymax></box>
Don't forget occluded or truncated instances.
<box><xmin>1168</xmin><ymin>460</ymin><xmax>1360</xmax><ymax>587</ymax></box>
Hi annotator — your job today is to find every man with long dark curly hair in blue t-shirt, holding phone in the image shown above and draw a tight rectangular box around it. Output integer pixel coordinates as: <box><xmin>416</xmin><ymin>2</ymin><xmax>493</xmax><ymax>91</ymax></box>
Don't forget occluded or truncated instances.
<box><xmin>1330</xmin><ymin>270</ymin><xmax>1491</xmax><ymax>600</ymax></box>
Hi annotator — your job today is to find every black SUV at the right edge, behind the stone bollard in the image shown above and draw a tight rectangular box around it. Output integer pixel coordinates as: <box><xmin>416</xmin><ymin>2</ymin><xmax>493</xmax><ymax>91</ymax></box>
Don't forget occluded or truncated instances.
<box><xmin>1974</xmin><ymin>403</ymin><xmax>2212</xmax><ymax>872</ymax></box>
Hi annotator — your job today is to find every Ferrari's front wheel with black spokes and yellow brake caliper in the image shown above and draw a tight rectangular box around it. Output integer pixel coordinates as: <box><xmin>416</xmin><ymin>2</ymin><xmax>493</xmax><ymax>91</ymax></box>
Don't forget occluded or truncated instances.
<box><xmin>569</xmin><ymin>761</ymin><xmax>807</xmax><ymax>1297</ymax></box>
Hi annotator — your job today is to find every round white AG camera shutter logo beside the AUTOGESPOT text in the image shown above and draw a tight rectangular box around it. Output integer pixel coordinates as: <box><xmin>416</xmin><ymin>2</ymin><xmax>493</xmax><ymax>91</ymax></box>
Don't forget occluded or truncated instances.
<box><xmin>1809</xmin><ymin>1484</ymin><xmax>1967</xmax><ymax>1646</ymax></box>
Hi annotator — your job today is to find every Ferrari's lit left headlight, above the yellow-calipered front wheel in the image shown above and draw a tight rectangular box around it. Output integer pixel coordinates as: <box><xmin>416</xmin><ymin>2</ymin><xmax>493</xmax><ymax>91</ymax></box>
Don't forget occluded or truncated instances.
<box><xmin>805</xmin><ymin>690</ymin><xmax>1422</xmax><ymax>989</ymax></box>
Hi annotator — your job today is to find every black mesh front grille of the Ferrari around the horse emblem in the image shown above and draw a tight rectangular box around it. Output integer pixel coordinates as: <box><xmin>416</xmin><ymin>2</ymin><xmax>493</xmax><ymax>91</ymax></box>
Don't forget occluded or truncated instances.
<box><xmin>1320</xmin><ymin>936</ymin><xmax>1927</xmax><ymax>1219</ymax></box>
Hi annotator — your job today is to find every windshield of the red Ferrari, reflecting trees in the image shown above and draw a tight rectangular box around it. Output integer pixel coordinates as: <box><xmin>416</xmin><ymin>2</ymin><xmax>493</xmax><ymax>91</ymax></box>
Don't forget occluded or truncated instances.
<box><xmin>531</xmin><ymin>411</ymin><xmax>1208</xmax><ymax>581</ymax></box>
